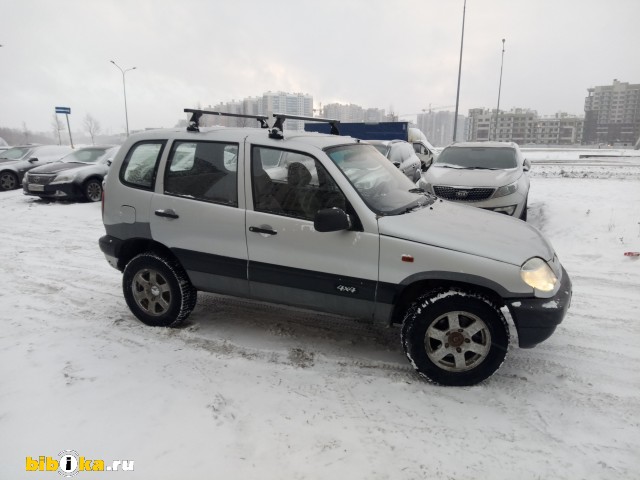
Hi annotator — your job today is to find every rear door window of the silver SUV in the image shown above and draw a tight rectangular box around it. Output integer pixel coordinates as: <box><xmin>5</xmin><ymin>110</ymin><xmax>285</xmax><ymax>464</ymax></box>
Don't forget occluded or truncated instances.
<box><xmin>164</xmin><ymin>141</ymin><xmax>238</xmax><ymax>207</ymax></box>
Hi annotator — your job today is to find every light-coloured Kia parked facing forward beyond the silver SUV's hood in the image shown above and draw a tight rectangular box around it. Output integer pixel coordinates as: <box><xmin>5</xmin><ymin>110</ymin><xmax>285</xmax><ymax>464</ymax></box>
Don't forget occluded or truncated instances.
<box><xmin>418</xmin><ymin>142</ymin><xmax>531</xmax><ymax>220</ymax></box>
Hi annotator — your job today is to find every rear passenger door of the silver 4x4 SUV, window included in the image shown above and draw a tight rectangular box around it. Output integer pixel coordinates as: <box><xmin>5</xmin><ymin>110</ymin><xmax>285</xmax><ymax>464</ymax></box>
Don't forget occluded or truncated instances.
<box><xmin>150</xmin><ymin>140</ymin><xmax>248</xmax><ymax>295</ymax></box>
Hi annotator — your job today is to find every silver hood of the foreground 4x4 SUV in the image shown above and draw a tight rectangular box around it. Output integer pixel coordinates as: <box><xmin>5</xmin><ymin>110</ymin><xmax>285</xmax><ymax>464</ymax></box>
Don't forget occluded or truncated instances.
<box><xmin>378</xmin><ymin>200</ymin><xmax>554</xmax><ymax>266</ymax></box>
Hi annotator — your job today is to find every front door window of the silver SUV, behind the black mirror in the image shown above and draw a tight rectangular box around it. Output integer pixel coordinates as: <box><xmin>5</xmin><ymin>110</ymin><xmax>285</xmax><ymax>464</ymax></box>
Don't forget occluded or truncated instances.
<box><xmin>251</xmin><ymin>146</ymin><xmax>347</xmax><ymax>220</ymax></box>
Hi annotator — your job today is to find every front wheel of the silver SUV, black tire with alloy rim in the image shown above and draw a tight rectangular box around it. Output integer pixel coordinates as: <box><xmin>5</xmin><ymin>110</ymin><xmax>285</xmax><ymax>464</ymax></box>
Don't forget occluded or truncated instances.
<box><xmin>401</xmin><ymin>289</ymin><xmax>509</xmax><ymax>386</ymax></box>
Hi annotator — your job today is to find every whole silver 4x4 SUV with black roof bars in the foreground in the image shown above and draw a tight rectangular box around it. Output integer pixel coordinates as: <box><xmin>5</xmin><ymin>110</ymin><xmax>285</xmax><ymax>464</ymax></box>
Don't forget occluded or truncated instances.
<box><xmin>100</xmin><ymin>110</ymin><xmax>571</xmax><ymax>385</ymax></box>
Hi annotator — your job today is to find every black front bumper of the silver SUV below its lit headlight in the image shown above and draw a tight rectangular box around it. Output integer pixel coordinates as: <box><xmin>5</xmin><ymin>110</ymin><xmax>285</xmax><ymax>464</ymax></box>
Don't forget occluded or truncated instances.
<box><xmin>507</xmin><ymin>267</ymin><xmax>572</xmax><ymax>348</ymax></box>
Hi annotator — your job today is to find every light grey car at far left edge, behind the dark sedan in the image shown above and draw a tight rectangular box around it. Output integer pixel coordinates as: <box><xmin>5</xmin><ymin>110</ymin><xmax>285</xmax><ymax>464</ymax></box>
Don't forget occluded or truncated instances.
<box><xmin>0</xmin><ymin>145</ymin><xmax>73</xmax><ymax>190</ymax></box>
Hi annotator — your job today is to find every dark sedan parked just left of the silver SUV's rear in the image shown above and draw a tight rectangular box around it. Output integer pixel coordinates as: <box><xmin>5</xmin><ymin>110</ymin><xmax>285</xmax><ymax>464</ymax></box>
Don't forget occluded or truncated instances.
<box><xmin>22</xmin><ymin>145</ymin><xmax>120</xmax><ymax>202</ymax></box>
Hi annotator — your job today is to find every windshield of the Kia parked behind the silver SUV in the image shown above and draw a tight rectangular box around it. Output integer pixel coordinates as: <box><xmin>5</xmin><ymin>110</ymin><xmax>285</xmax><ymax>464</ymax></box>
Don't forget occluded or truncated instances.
<box><xmin>434</xmin><ymin>147</ymin><xmax>518</xmax><ymax>170</ymax></box>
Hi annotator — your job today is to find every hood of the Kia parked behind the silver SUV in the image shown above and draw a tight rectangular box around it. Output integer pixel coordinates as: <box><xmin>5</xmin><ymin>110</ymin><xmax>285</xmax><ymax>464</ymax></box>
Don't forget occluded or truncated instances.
<box><xmin>424</xmin><ymin>165</ymin><xmax>521</xmax><ymax>188</ymax></box>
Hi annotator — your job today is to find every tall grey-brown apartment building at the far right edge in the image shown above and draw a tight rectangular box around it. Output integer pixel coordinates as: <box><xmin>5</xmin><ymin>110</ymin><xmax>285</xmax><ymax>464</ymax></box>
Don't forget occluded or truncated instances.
<box><xmin>582</xmin><ymin>80</ymin><xmax>640</xmax><ymax>145</ymax></box>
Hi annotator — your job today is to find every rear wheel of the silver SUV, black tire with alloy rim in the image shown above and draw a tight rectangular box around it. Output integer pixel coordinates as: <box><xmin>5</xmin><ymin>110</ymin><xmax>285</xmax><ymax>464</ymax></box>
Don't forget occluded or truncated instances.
<box><xmin>122</xmin><ymin>253</ymin><xmax>198</xmax><ymax>327</ymax></box>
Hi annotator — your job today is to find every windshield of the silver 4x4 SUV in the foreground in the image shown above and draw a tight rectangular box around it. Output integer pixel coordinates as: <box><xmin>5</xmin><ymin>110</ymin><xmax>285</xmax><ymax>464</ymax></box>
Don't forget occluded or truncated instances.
<box><xmin>325</xmin><ymin>144</ymin><xmax>433</xmax><ymax>215</ymax></box>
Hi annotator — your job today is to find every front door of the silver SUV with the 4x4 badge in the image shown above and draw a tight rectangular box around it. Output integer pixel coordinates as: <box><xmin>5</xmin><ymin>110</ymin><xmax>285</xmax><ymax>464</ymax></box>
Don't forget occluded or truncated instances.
<box><xmin>245</xmin><ymin>144</ymin><xmax>379</xmax><ymax>318</ymax></box>
